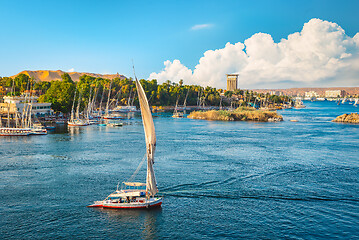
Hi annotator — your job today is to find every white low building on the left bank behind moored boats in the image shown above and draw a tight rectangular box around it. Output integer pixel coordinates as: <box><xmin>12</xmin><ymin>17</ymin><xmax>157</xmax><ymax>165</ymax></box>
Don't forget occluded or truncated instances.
<box><xmin>0</xmin><ymin>96</ymin><xmax>54</xmax><ymax>116</ymax></box>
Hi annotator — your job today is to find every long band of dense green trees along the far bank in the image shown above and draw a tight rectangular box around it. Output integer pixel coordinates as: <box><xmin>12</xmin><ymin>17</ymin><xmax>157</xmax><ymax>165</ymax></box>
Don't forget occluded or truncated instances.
<box><xmin>0</xmin><ymin>73</ymin><xmax>289</xmax><ymax>113</ymax></box>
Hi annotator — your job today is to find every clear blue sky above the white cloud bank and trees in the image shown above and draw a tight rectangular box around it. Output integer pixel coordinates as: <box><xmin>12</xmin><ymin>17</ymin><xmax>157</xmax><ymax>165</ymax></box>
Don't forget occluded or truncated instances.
<box><xmin>0</xmin><ymin>0</ymin><xmax>359</xmax><ymax>88</ymax></box>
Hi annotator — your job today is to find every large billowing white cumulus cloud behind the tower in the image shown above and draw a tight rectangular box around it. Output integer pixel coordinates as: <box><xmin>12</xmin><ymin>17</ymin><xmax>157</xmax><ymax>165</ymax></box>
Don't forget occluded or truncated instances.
<box><xmin>149</xmin><ymin>18</ymin><xmax>359</xmax><ymax>88</ymax></box>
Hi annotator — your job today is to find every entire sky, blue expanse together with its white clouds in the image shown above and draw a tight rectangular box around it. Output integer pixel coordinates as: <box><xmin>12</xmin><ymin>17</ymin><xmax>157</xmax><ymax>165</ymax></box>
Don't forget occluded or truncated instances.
<box><xmin>0</xmin><ymin>0</ymin><xmax>359</xmax><ymax>88</ymax></box>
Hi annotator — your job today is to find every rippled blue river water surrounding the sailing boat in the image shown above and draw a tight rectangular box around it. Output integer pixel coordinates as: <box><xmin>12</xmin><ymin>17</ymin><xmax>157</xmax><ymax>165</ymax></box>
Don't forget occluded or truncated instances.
<box><xmin>0</xmin><ymin>102</ymin><xmax>359</xmax><ymax>239</ymax></box>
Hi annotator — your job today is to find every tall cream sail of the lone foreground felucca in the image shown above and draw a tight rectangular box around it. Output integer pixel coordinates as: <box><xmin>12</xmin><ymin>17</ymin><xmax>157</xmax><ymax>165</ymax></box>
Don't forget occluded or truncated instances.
<box><xmin>136</xmin><ymin>78</ymin><xmax>158</xmax><ymax>196</ymax></box>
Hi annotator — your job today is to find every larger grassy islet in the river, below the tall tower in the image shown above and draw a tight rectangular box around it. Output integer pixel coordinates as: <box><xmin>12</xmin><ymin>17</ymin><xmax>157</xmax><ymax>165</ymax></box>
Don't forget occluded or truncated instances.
<box><xmin>188</xmin><ymin>107</ymin><xmax>283</xmax><ymax>122</ymax></box>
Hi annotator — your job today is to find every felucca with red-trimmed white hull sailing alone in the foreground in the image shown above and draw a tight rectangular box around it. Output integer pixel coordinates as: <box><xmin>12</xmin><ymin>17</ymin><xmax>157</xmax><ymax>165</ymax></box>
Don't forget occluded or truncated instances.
<box><xmin>88</xmin><ymin>78</ymin><xmax>163</xmax><ymax>208</ymax></box>
